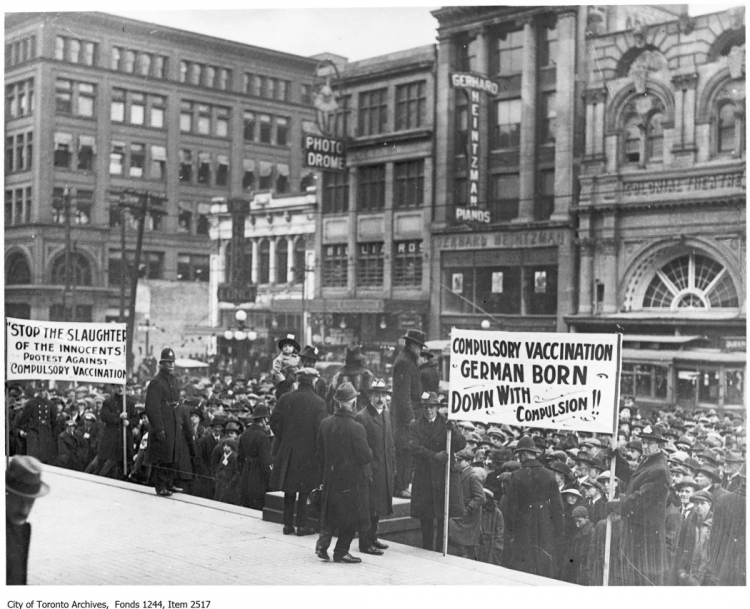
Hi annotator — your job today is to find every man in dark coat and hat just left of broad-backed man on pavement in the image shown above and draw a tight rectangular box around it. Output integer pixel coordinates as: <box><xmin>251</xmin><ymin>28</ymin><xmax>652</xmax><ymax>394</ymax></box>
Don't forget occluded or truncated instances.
<box><xmin>237</xmin><ymin>404</ymin><xmax>271</xmax><ymax>510</ymax></box>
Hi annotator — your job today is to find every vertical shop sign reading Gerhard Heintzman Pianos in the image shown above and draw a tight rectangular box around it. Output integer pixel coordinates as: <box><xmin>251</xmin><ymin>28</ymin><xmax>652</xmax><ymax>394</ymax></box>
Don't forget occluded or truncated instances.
<box><xmin>451</xmin><ymin>73</ymin><xmax>500</xmax><ymax>224</ymax></box>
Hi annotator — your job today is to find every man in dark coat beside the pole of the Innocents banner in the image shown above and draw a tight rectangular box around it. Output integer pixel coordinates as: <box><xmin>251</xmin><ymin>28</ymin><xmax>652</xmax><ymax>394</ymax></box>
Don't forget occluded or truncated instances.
<box><xmin>97</xmin><ymin>385</ymin><xmax>139</xmax><ymax>479</ymax></box>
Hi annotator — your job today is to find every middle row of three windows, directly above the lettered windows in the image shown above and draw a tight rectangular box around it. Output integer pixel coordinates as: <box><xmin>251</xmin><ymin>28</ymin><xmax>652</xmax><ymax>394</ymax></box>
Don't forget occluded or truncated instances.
<box><xmin>322</xmin><ymin>159</ymin><xmax>424</xmax><ymax>214</ymax></box>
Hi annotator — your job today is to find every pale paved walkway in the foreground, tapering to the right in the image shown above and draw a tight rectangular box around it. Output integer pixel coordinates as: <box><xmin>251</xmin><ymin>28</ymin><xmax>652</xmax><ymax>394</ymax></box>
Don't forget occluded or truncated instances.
<box><xmin>29</xmin><ymin>466</ymin><xmax>562</xmax><ymax>586</ymax></box>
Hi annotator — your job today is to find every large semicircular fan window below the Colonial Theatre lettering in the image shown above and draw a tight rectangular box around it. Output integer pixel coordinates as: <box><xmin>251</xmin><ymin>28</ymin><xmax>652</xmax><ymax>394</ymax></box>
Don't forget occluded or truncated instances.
<box><xmin>643</xmin><ymin>252</ymin><xmax>740</xmax><ymax>310</ymax></box>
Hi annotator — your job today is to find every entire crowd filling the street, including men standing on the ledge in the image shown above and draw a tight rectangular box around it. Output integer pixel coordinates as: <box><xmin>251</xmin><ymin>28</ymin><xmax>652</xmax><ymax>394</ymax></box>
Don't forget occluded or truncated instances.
<box><xmin>8</xmin><ymin>330</ymin><xmax>746</xmax><ymax>586</ymax></box>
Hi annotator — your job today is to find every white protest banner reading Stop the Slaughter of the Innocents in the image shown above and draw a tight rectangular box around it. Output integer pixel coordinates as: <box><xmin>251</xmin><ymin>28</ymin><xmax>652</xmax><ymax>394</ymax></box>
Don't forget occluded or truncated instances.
<box><xmin>5</xmin><ymin>317</ymin><xmax>126</xmax><ymax>385</ymax></box>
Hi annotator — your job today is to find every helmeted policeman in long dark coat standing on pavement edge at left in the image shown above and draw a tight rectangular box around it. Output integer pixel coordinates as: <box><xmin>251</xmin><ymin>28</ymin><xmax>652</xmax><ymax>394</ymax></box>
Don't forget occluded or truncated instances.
<box><xmin>146</xmin><ymin>347</ymin><xmax>182</xmax><ymax>497</ymax></box>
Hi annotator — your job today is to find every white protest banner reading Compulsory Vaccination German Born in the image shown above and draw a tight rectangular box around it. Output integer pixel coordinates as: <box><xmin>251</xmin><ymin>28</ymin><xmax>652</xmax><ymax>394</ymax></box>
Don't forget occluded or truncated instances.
<box><xmin>448</xmin><ymin>329</ymin><xmax>620</xmax><ymax>434</ymax></box>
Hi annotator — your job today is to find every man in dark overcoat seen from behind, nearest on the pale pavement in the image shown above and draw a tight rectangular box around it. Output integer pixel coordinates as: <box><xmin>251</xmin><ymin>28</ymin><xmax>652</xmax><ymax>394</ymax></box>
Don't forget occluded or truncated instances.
<box><xmin>315</xmin><ymin>382</ymin><xmax>372</xmax><ymax>564</ymax></box>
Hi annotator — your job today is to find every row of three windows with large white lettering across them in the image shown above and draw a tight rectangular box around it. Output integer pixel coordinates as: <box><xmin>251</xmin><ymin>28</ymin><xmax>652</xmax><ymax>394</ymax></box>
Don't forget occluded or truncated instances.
<box><xmin>321</xmin><ymin>240</ymin><xmax>423</xmax><ymax>288</ymax></box>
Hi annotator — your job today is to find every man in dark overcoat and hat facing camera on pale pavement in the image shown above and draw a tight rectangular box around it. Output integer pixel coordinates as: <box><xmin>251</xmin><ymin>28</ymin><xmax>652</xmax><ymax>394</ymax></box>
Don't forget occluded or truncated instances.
<box><xmin>354</xmin><ymin>379</ymin><xmax>396</xmax><ymax>555</ymax></box>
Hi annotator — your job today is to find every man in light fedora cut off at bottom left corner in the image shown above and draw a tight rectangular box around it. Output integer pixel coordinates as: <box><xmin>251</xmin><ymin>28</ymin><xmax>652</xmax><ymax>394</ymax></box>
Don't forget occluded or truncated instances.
<box><xmin>5</xmin><ymin>455</ymin><xmax>49</xmax><ymax>586</ymax></box>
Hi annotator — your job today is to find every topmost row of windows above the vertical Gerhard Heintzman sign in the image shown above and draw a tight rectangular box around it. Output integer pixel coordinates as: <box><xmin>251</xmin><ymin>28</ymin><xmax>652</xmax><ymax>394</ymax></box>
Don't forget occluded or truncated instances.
<box><xmin>454</xmin><ymin>24</ymin><xmax>558</xmax><ymax>77</ymax></box>
